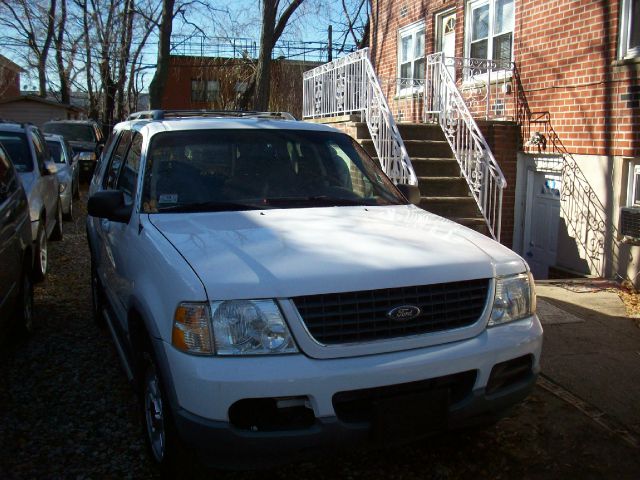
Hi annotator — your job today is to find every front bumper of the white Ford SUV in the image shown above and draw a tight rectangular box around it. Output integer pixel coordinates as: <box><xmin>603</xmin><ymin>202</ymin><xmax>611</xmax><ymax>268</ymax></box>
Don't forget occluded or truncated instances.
<box><xmin>162</xmin><ymin>316</ymin><xmax>542</xmax><ymax>468</ymax></box>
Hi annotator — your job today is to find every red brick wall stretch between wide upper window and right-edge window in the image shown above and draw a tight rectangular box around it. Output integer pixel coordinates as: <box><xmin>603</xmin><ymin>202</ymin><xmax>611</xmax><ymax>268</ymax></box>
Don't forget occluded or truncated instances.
<box><xmin>515</xmin><ymin>0</ymin><xmax>640</xmax><ymax>156</ymax></box>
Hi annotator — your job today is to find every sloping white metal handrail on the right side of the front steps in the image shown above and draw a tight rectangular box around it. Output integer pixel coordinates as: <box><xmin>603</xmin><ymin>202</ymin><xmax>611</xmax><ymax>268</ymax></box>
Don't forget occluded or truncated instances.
<box><xmin>427</xmin><ymin>52</ymin><xmax>507</xmax><ymax>241</ymax></box>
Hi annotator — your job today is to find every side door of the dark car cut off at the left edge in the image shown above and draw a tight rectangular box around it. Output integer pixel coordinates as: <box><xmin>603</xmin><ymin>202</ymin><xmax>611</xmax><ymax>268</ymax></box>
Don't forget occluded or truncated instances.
<box><xmin>0</xmin><ymin>147</ymin><xmax>22</xmax><ymax>327</ymax></box>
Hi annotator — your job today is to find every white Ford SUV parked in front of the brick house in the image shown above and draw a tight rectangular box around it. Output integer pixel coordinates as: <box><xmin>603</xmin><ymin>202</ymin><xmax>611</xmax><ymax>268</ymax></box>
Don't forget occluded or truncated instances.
<box><xmin>87</xmin><ymin>111</ymin><xmax>542</xmax><ymax>474</ymax></box>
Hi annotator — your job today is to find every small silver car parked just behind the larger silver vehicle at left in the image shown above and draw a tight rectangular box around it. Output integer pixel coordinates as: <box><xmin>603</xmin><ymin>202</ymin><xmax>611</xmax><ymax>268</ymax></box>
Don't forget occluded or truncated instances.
<box><xmin>44</xmin><ymin>135</ymin><xmax>80</xmax><ymax>220</ymax></box>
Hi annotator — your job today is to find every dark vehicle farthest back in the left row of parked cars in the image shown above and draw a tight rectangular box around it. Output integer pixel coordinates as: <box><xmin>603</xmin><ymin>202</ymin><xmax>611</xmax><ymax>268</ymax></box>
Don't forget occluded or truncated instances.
<box><xmin>42</xmin><ymin>120</ymin><xmax>105</xmax><ymax>179</ymax></box>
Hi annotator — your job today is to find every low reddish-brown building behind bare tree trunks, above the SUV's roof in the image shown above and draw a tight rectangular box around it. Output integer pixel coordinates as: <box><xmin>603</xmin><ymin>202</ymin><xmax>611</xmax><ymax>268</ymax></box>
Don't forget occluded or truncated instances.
<box><xmin>162</xmin><ymin>55</ymin><xmax>319</xmax><ymax>117</ymax></box>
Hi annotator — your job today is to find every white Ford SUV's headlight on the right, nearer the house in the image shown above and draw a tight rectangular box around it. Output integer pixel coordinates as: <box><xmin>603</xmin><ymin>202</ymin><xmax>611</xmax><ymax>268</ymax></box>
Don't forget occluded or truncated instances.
<box><xmin>488</xmin><ymin>273</ymin><xmax>536</xmax><ymax>327</ymax></box>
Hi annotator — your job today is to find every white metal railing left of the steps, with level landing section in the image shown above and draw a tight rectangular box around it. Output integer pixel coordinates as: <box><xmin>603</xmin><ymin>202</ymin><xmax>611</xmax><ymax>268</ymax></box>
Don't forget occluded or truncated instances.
<box><xmin>302</xmin><ymin>48</ymin><xmax>418</xmax><ymax>185</ymax></box>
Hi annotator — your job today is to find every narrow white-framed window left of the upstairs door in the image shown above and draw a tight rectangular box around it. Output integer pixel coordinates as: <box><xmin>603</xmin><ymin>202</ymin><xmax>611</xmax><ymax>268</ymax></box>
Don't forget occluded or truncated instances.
<box><xmin>398</xmin><ymin>22</ymin><xmax>426</xmax><ymax>94</ymax></box>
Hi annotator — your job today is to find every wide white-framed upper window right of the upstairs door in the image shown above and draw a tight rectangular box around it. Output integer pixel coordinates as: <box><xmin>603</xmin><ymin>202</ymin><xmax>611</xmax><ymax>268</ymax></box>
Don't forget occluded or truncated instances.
<box><xmin>465</xmin><ymin>0</ymin><xmax>515</xmax><ymax>64</ymax></box>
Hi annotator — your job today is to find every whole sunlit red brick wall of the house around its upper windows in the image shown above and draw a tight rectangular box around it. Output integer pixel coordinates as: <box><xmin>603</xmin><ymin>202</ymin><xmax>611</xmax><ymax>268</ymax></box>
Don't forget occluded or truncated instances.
<box><xmin>370</xmin><ymin>0</ymin><xmax>640</xmax><ymax>157</ymax></box>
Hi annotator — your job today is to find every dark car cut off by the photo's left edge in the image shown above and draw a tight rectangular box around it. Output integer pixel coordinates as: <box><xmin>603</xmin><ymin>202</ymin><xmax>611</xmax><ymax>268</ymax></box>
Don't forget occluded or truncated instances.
<box><xmin>0</xmin><ymin>146</ymin><xmax>33</xmax><ymax>339</ymax></box>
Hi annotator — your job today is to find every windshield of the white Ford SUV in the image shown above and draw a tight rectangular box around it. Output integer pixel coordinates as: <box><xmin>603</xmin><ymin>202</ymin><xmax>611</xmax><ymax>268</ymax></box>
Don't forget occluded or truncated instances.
<box><xmin>142</xmin><ymin>129</ymin><xmax>406</xmax><ymax>213</ymax></box>
